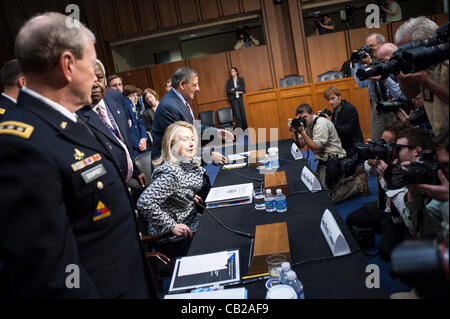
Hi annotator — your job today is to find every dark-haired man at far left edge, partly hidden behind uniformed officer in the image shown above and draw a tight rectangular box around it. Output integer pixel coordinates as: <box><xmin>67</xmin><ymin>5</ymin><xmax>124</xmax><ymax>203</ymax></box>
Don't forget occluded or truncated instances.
<box><xmin>0</xmin><ymin>59</ymin><xmax>25</xmax><ymax>121</ymax></box>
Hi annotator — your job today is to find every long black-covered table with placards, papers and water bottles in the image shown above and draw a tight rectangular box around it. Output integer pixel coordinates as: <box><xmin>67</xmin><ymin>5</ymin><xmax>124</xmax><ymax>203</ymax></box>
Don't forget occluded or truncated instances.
<box><xmin>188</xmin><ymin>140</ymin><xmax>387</xmax><ymax>299</ymax></box>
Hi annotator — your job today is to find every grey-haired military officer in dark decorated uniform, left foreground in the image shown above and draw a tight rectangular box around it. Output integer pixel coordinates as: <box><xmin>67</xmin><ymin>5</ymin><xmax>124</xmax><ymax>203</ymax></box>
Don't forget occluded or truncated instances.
<box><xmin>0</xmin><ymin>13</ymin><xmax>156</xmax><ymax>298</ymax></box>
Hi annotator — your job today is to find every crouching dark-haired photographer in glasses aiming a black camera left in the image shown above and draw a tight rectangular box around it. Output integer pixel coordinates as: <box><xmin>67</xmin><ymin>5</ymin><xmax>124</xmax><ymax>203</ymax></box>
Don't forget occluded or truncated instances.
<box><xmin>345</xmin><ymin>127</ymin><xmax>432</xmax><ymax>261</ymax></box>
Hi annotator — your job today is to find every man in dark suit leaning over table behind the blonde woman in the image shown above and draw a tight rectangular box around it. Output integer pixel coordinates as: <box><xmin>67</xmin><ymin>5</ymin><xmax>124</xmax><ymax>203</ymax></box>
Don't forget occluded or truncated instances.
<box><xmin>152</xmin><ymin>67</ymin><xmax>234</xmax><ymax>164</ymax></box>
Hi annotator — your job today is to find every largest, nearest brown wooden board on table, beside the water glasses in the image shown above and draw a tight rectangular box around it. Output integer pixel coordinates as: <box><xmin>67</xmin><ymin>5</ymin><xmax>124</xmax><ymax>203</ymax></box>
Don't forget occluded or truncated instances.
<box><xmin>248</xmin><ymin>222</ymin><xmax>291</xmax><ymax>275</ymax></box>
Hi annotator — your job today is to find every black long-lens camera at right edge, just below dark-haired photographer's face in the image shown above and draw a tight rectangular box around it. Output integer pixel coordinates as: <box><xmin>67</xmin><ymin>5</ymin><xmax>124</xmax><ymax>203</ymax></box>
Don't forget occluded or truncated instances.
<box><xmin>384</xmin><ymin>150</ymin><xmax>441</xmax><ymax>189</ymax></box>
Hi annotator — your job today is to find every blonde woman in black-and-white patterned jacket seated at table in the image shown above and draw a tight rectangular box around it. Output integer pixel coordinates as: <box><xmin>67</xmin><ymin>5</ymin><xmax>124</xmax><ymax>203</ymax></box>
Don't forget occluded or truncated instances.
<box><xmin>137</xmin><ymin>121</ymin><xmax>205</xmax><ymax>259</ymax></box>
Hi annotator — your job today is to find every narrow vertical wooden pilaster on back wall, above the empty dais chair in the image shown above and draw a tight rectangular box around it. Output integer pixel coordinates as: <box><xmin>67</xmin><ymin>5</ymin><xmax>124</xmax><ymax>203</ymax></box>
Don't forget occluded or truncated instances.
<box><xmin>289</xmin><ymin>0</ymin><xmax>312</xmax><ymax>83</ymax></box>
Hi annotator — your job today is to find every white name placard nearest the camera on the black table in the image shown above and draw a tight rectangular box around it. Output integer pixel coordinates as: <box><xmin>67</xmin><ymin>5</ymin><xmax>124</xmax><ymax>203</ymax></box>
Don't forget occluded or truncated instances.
<box><xmin>320</xmin><ymin>209</ymin><xmax>350</xmax><ymax>256</ymax></box>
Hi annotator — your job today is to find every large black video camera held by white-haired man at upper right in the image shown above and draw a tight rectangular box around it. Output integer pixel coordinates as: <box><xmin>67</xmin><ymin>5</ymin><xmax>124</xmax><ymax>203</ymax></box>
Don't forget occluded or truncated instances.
<box><xmin>356</xmin><ymin>24</ymin><xmax>449</xmax><ymax>81</ymax></box>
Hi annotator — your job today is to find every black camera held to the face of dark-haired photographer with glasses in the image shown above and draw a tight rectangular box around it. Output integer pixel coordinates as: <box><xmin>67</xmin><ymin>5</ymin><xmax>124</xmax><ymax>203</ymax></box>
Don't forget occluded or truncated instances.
<box><xmin>353</xmin><ymin>139</ymin><xmax>398</xmax><ymax>163</ymax></box>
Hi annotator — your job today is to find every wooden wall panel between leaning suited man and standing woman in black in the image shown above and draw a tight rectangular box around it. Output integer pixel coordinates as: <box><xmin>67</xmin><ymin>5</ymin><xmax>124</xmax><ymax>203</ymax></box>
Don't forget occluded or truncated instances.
<box><xmin>189</xmin><ymin>53</ymin><xmax>229</xmax><ymax>104</ymax></box>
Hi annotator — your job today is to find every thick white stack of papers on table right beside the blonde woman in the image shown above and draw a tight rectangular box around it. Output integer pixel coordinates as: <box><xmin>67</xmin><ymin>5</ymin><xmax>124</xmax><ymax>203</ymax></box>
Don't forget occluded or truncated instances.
<box><xmin>205</xmin><ymin>183</ymin><xmax>253</xmax><ymax>208</ymax></box>
